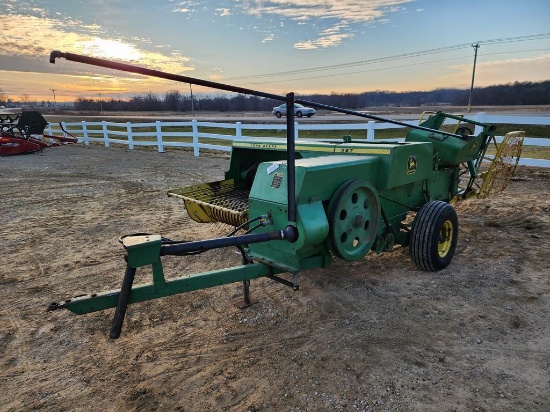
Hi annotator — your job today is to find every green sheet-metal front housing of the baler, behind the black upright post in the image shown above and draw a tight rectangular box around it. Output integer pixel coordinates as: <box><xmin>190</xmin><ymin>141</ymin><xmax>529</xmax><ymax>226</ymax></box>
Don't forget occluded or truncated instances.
<box><xmin>249</xmin><ymin>155</ymin><xmax>381</xmax><ymax>272</ymax></box>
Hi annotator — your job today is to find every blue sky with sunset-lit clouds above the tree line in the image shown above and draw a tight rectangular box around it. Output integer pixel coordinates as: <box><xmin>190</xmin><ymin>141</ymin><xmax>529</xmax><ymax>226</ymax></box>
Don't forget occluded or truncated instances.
<box><xmin>0</xmin><ymin>0</ymin><xmax>550</xmax><ymax>101</ymax></box>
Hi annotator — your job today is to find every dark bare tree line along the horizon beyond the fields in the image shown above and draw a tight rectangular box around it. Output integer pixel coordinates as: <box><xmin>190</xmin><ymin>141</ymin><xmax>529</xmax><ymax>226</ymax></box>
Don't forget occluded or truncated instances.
<box><xmin>0</xmin><ymin>80</ymin><xmax>550</xmax><ymax>112</ymax></box>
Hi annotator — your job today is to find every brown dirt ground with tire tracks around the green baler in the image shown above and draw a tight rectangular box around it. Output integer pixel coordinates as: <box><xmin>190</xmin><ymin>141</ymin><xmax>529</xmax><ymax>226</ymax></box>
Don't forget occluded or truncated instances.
<box><xmin>0</xmin><ymin>145</ymin><xmax>550</xmax><ymax>411</ymax></box>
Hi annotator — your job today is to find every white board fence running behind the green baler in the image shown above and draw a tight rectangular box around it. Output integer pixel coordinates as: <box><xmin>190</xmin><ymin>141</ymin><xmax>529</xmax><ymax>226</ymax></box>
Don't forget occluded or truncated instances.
<box><xmin>47</xmin><ymin>113</ymin><xmax>550</xmax><ymax>168</ymax></box>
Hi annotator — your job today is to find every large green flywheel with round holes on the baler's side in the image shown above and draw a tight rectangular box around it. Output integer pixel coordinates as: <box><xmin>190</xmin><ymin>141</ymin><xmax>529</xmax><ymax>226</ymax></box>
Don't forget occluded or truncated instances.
<box><xmin>328</xmin><ymin>180</ymin><xmax>380</xmax><ymax>261</ymax></box>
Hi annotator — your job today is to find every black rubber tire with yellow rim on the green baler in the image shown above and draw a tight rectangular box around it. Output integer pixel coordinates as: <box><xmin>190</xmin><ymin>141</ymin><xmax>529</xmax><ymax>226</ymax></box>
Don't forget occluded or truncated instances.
<box><xmin>409</xmin><ymin>200</ymin><xmax>458</xmax><ymax>272</ymax></box>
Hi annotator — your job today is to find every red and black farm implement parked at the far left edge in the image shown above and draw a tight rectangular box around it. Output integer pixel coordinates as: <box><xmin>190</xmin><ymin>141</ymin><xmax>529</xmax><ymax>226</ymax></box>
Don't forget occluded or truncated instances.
<box><xmin>0</xmin><ymin>111</ymin><xmax>78</xmax><ymax>156</ymax></box>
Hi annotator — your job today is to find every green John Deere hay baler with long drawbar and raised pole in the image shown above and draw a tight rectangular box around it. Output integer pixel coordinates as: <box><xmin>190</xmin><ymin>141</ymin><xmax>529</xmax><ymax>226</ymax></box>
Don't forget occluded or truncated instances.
<box><xmin>49</xmin><ymin>51</ymin><xmax>528</xmax><ymax>339</ymax></box>
